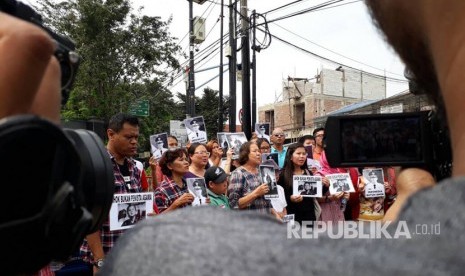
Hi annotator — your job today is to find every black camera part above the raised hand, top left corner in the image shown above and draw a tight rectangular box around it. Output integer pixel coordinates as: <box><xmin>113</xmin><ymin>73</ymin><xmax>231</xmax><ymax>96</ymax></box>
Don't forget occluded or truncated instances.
<box><xmin>0</xmin><ymin>0</ymin><xmax>81</xmax><ymax>106</ymax></box>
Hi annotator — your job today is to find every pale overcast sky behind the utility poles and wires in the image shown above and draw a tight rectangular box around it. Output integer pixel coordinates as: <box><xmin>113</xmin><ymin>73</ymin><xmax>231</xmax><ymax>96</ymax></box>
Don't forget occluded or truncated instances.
<box><xmin>26</xmin><ymin>0</ymin><xmax>407</xmax><ymax>116</ymax></box>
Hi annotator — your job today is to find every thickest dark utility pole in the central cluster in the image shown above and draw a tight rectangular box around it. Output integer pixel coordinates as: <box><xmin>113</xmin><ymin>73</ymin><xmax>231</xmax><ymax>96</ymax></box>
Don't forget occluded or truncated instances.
<box><xmin>241</xmin><ymin>0</ymin><xmax>252</xmax><ymax>139</ymax></box>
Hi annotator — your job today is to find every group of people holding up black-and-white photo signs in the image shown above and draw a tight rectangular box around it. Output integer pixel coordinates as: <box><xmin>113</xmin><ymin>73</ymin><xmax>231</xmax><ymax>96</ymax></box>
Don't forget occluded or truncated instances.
<box><xmin>66</xmin><ymin>122</ymin><xmax>396</xmax><ymax>270</ymax></box>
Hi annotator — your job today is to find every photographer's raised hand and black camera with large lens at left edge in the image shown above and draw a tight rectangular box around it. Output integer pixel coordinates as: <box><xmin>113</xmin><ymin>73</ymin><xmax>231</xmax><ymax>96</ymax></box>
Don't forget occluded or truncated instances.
<box><xmin>0</xmin><ymin>0</ymin><xmax>114</xmax><ymax>275</ymax></box>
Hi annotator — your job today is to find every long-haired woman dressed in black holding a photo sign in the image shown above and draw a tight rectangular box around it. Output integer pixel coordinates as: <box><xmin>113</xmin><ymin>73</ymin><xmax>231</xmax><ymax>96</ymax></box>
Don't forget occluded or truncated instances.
<box><xmin>278</xmin><ymin>143</ymin><xmax>318</xmax><ymax>223</ymax></box>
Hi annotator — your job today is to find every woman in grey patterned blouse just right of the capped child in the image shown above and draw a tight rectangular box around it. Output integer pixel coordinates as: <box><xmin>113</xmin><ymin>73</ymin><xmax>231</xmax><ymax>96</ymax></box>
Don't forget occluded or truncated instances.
<box><xmin>228</xmin><ymin>142</ymin><xmax>274</xmax><ymax>213</ymax></box>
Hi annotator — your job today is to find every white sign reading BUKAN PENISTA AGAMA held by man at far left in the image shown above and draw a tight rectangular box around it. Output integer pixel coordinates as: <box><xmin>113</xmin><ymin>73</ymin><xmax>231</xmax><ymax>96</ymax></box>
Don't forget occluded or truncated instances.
<box><xmin>109</xmin><ymin>193</ymin><xmax>153</xmax><ymax>231</ymax></box>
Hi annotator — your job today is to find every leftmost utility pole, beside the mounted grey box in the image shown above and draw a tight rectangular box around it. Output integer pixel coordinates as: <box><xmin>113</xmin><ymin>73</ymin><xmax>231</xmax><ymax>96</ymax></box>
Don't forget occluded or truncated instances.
<box><xmin>186</xmin><ymin>0</ymin><xmax>195</xmax><ymax>117</ymax></box>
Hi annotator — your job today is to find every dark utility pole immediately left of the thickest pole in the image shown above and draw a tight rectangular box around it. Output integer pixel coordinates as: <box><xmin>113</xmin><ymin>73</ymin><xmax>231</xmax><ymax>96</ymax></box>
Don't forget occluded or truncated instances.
<box><xmin>229</xmin><ymin>0</ymin><xmax>237</xmax><ymax>132</ymax></box>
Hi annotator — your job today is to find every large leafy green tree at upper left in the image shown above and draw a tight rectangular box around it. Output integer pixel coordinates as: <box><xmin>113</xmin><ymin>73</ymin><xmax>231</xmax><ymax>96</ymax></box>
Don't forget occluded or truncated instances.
<box><xmin>39</xmin><ymin>0</ymin><xmax>180</xmax><ymax>123</ymax></box>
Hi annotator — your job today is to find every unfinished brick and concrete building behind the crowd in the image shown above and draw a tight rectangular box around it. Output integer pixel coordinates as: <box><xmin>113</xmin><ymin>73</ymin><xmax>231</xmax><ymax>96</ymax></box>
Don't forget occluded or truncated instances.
<box><xmin>258</xmin><ymin>67</ymin><xmax>386</xmax><ymax>141</ymax></box>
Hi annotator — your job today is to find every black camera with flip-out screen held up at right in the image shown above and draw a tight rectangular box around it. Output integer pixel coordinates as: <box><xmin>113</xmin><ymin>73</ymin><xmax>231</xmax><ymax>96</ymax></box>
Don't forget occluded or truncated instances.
<box><xmin>325</xmin><ymin>111</ymin><xmax>452</xmax><ymax>180</ymax></box>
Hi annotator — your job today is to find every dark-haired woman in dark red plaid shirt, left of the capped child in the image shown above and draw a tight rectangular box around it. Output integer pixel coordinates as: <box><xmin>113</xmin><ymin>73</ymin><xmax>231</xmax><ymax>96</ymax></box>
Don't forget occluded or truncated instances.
<box><xmin>154</xmin><ymin>148</ymin><xmax>194</xmax><ymax>213</ymax></box>
